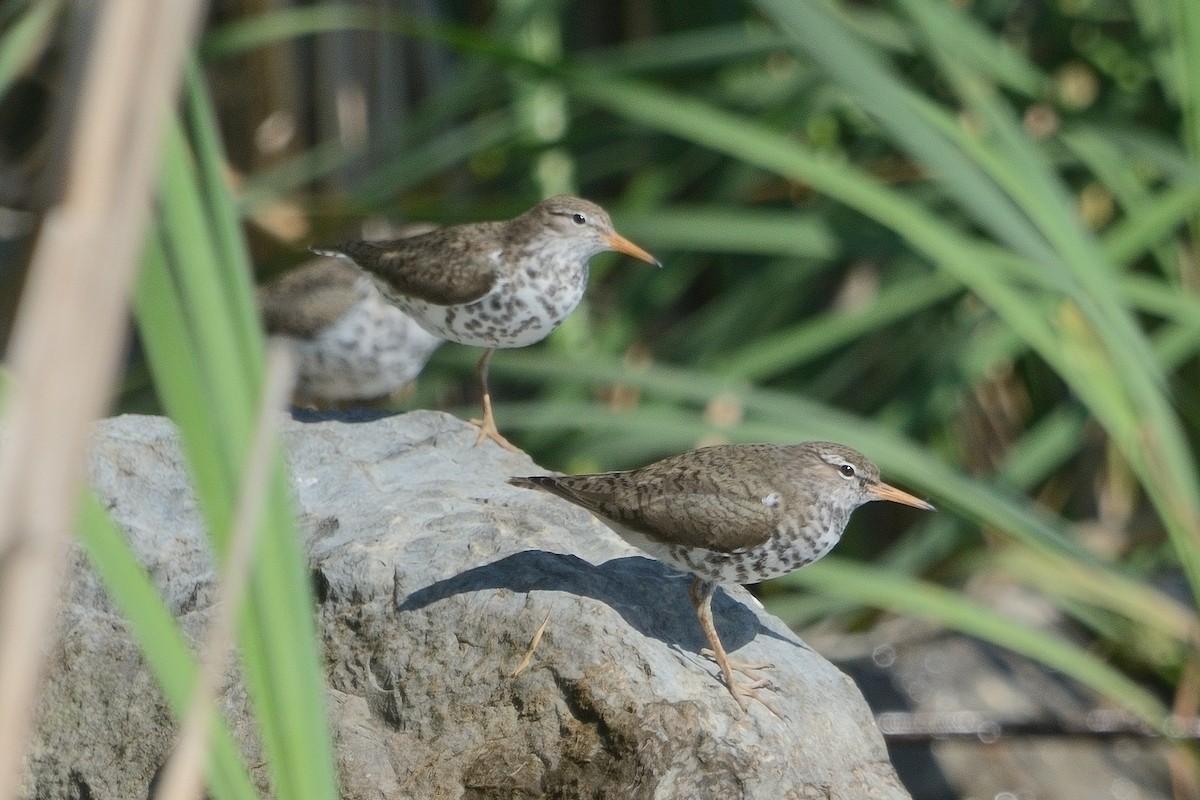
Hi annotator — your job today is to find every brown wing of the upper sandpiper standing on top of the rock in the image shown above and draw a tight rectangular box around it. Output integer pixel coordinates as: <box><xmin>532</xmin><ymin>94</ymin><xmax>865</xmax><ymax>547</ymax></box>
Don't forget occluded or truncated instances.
<box><xmin>320</xmin><ymin>225</ymin><xmax>497</xmax><ymax>306</ymax></box>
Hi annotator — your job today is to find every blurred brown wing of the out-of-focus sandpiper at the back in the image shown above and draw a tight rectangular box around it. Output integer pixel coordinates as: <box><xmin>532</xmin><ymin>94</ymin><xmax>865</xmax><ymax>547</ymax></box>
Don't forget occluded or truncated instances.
<box><xmin>258</xmin><ymin>258</ymin><xmax>362</xmax><ymax>338</ymax></box>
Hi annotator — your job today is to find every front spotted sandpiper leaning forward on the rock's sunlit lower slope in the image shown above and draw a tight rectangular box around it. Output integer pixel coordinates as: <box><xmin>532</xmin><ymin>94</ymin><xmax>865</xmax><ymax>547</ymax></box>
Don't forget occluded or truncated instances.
<box><xmin>509</xmin><ymin>441</ymin><xmax>934</xmax><ymax>710</ymax></box>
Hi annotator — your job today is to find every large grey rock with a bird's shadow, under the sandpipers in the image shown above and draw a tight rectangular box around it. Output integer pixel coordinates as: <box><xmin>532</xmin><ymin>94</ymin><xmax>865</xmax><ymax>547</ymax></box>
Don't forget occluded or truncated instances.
<box><xmin>23</xmin><ymin>411</ymin><xmax>908</xmax><ymax>800</ymax></box>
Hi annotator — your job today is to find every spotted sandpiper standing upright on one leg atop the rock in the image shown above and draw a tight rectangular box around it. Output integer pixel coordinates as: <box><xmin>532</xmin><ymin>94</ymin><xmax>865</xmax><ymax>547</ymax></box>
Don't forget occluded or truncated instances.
<box><xmin>313</xmin><ymin>196</ymin><xmax>661</xmax><ymax>450</ymax></box>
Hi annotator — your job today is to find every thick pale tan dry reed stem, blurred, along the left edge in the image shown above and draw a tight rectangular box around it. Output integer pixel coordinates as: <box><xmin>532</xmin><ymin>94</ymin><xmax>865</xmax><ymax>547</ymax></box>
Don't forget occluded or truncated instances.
<box><xmin>0</xmin><ymin>0</ymin><xmax>200</xmax><ymax>800</ymax></box>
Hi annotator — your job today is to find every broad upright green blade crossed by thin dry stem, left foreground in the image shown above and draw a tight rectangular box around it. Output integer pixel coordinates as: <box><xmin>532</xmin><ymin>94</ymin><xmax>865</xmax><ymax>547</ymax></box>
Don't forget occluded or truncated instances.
<box><xmin>138</xmin><ymin>107</ymin><xmax>336</xmax><ymax>799</ymax></box>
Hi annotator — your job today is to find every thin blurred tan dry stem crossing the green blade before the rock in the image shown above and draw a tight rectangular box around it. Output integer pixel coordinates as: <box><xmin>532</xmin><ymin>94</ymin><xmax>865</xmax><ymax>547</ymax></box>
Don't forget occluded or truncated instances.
<box><xmin>155</xmin><ymin>343</ymin><xmax>296</xmax><ymax>800</ymax></box>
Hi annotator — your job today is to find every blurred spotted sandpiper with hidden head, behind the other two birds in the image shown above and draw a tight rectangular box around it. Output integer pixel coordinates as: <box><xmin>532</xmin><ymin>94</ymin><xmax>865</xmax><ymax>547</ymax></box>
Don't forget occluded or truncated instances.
<box><xmin>258</xmin><ymin>258</ymin><xmax>442</xmax><ymax>408</ymax></box>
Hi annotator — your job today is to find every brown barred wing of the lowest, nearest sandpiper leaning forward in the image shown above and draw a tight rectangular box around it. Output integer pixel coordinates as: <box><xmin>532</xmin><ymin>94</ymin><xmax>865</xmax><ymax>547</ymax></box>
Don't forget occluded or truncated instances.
<box><xmin>511</xmin><ymin>462</ymin><xmax>784</xmax><ymax>553</ymax></box>
